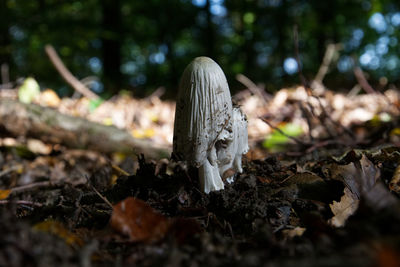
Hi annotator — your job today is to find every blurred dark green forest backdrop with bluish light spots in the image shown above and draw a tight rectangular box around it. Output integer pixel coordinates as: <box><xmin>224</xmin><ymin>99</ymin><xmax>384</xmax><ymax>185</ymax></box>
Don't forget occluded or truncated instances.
<box><xmin>0</xmin><ymin>0</ymin><xmax>400</xmax><ymax>97</ymax></box>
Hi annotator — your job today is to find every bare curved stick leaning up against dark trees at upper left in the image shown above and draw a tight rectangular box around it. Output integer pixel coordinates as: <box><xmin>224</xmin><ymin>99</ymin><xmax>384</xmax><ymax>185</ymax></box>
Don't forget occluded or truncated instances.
<box><xmin>45</xmin><ymin>45</ymin><xmax>99</xmax><ymax>99</ymax></box>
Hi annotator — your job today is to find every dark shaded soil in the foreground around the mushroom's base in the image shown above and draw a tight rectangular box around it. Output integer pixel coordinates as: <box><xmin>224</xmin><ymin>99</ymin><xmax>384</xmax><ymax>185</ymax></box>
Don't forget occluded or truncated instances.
<box><xmin>0</xmin><ymin>148</ymin><xmax>400</xmax><ymax>266</ymax></box>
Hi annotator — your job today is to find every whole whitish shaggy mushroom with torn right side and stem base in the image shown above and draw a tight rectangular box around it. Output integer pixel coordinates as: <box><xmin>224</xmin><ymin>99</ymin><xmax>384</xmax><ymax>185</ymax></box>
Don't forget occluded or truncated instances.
<box><xmin>173</xmin><ymin>57</ymin><xmax>247</xmax><ymax>194</ymax></box>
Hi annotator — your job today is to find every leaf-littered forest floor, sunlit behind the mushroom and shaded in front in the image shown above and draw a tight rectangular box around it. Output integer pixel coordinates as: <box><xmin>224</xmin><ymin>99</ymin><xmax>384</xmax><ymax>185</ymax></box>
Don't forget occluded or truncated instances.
<box><xmin>0</xmin><ymin>84</ymin><xmax>400</xmax><ymax>266</ymax></box>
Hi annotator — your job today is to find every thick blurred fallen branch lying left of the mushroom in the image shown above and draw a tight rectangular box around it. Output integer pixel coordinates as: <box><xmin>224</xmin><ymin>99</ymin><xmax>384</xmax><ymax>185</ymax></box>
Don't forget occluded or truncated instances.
<box><xmin>0</xmin><ymin>99</ymin><xmax>169</xmax><ymax>158</ymax></box>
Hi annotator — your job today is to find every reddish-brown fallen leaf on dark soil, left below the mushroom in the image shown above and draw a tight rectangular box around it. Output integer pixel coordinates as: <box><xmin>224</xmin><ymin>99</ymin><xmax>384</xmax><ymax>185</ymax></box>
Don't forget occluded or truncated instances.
<box><xmin>111</xmin><ymin>197</ymin><xmax>171</xmax><ymax>242</ymax></box>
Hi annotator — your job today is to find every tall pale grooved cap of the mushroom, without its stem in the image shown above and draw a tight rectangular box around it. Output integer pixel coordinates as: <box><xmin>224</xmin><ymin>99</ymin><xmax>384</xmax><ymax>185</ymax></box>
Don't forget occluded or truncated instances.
<box><xmin>173</xmin><ymin>57</ymin><xmax>233</xmax><ymax>167</ymax></box>
